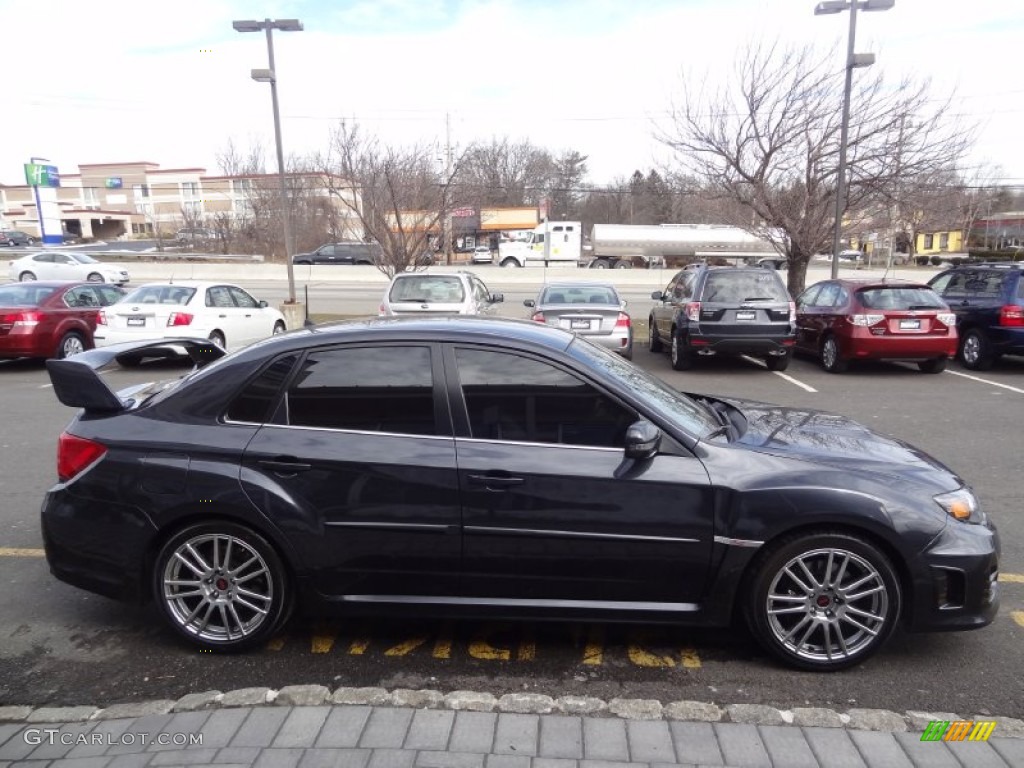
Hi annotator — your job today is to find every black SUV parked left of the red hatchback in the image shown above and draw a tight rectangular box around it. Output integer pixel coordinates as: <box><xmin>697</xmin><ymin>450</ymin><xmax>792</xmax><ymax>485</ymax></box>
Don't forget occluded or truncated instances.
<box><xmin>649</xmin><ymin>264</ymin><xmax>797</xmax><ymax>371</ymax></box>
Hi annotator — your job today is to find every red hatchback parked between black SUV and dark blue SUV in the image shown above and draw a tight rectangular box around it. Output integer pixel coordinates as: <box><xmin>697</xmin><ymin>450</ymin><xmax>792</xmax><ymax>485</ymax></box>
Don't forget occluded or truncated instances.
<box><xmin>797</xmin><ymin>280</ymin><xmax>957</xmax><ymax>374</ymax></box>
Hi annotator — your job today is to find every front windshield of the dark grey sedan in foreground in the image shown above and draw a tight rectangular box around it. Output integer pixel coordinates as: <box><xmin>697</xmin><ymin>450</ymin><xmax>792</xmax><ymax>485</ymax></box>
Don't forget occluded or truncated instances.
<box><xmin>568</xmin><ymin>336</ymin><xmax>721</xmax><ymax>437</ymax></box>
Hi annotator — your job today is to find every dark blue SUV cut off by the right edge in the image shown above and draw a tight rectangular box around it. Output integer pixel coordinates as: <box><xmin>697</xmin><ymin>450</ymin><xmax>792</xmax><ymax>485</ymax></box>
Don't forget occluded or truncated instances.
<box><xmin>928</xmin><ymin>263</ymin><xmax>1024</xmax><ymax>371</ymax></box>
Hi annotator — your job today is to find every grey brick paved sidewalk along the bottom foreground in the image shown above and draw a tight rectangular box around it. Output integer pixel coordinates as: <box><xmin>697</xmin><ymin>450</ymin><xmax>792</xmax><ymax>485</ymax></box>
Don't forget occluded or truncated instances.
<box><xmin>0</xmin><ymin>705</ymin><xmax>1024</xmax><ymax>768</ymax></box>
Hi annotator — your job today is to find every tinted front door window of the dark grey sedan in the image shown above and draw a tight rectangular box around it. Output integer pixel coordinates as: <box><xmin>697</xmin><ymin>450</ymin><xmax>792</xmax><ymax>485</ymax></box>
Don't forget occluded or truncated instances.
<box><xmin>456</xmin><ymin>349</ymin><xmax>636</xmax><ymax>447</ymax></box>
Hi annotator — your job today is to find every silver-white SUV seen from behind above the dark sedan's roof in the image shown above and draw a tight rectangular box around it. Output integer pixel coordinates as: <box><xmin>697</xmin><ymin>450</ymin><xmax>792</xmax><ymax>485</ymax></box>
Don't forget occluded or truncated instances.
<box><xmin>380</xmin><ymin>271</ymin><xmax>505</xmax><ymax>316</ymax></box>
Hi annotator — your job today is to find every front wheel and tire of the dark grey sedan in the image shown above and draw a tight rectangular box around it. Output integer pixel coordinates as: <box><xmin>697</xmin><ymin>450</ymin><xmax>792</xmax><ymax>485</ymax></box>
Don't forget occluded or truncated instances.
<box><xmin>744</xmin><ymin>531</ymin><xmax>902</xmax><ymax>672</ymax></box>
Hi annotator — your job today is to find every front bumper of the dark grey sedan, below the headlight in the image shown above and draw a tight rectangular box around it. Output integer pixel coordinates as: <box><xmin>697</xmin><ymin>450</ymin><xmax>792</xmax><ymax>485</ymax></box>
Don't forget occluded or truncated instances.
<box><xmin>906</xmin><ymin>520</ymin><xmax>999</xmax><ymax>632</ymax></box>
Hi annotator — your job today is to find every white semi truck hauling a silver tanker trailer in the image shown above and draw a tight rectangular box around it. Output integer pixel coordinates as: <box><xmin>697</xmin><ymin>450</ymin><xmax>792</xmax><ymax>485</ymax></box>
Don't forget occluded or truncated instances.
<box><xmin>496</xmin><ymin>221</ymin><xmax>784</xmax><ymax>269</ymax></box>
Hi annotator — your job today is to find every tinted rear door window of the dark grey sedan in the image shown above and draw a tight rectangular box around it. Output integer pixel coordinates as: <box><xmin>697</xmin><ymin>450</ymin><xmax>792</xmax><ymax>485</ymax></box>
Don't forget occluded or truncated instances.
<box><xmin>288</xmin><ymin>346</ymin><xmax>437</xmax><ymax>434</ymax></box>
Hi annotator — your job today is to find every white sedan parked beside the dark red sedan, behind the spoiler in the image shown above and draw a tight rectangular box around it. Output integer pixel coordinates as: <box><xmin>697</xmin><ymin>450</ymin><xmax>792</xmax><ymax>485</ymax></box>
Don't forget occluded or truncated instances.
<box><xmin>93</xmin><ymin>281</ymin><xmax>286</xmax><ymax>351</ymax></box>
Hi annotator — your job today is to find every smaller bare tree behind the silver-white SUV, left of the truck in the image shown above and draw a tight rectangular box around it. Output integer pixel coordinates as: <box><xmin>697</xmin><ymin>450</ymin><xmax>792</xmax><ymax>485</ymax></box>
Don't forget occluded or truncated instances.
<box><xmin>315</xmin><ymin>122</ymin><xmax>461</xmax><ymax>278</ymax></box>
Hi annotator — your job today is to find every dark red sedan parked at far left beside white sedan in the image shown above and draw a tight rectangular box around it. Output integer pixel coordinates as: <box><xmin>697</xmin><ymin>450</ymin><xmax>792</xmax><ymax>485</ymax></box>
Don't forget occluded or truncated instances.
<box><xmin>0</xmin><ymin>282</ymin><xmax>124</xmax><ymax>358</ymax></box>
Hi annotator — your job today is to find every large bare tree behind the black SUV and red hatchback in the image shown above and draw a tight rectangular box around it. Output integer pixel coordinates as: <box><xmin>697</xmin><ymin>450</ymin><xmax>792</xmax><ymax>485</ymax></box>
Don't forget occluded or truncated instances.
<box><xmin>657</xmin><ymin>44</ymin><xmax>973</xmax><ymax>294</ymax></box>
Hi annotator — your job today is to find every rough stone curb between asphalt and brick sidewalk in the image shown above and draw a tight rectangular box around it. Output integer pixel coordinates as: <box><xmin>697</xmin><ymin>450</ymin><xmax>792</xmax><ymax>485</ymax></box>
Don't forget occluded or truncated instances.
<box><xmin>0</xmin><ymin>685</ymin><xmax>1024</xmax><ymax>738</ymax></box>
